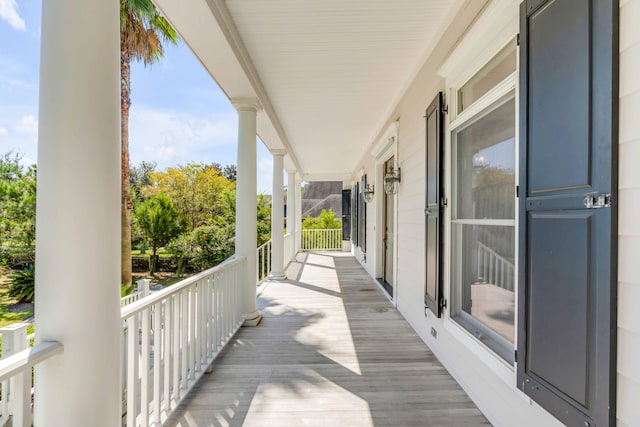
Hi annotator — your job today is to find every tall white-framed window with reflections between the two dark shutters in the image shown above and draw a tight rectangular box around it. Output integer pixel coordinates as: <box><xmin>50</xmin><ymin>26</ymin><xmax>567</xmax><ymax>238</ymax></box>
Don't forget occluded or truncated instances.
<box><xmin>449</xmin><ymin>40</ymin><xmax>516</xmax><ymax>363</ymax></box>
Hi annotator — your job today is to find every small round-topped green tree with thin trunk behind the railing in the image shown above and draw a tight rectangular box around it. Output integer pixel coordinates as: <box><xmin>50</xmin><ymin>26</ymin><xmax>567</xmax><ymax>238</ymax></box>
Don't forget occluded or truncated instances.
<box><xmin>135</xmin><ymin>194</ymin><xmax>182</xmax><ymax>274</ymax></box>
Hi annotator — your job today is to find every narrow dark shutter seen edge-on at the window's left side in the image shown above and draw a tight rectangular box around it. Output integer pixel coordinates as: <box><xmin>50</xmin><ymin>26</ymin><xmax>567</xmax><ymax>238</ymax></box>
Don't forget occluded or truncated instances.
<box><xmin>424</xmin><ymin>92</ymin><xmax>445</xmax><ymax>317</ymax></box>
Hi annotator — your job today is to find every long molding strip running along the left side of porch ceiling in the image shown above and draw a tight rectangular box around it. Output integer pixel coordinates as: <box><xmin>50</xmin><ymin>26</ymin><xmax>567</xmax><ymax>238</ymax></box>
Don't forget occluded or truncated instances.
<box><xmin>207</xmin><ymin>0</ymin><xmax>302</xmax><ymax>171</ymax></box>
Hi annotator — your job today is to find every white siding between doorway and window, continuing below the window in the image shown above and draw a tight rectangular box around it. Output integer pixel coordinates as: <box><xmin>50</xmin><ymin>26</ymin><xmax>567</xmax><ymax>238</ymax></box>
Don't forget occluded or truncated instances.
<box><xmin>384</xmin><ymin>1</ymin><xmax>559</xmax><ymax>427</ymax></box>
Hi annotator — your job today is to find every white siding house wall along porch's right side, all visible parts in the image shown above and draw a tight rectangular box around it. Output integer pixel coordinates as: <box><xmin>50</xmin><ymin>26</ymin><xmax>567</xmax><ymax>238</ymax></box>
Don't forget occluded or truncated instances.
<box><xmin>354</xmin><ymin>0</ymin><xmax>640</xmax><ymax>426</ymax></box>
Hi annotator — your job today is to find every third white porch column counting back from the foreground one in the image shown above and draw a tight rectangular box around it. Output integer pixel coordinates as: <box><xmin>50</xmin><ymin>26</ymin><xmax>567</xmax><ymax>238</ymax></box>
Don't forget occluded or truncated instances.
<box><xmin>269</xmin><ymin>150</ymin><xmax>286</xmax><ymax>280</ymax></box>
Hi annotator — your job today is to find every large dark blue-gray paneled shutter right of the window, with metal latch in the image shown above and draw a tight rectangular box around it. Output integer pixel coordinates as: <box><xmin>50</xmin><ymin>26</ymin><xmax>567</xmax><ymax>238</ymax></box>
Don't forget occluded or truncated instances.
<box><xmin>517</xmin><ymin>0</ymin><xmax>618</xmax><ymax>426</ymax></box>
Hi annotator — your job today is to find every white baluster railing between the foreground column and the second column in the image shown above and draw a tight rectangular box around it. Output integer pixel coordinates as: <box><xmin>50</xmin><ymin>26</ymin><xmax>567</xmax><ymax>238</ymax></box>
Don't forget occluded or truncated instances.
<box><xmin>121</xmin><ymin>257</ymin><xmax>246</xmax><ymax>427</ymax></box>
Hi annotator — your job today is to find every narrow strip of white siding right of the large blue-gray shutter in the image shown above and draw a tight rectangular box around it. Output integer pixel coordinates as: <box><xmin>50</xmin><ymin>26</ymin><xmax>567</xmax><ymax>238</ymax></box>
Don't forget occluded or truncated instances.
<box><xmin>617</xmin><ymin>0</ymin><xmax>640</xmax><ymax>426</ymax></box>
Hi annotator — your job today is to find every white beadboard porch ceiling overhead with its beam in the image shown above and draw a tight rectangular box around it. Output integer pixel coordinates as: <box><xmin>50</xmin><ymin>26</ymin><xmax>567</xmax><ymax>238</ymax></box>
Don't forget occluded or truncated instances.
<box><xmin>157</xmin><ymin>0</ymin><xmax>463</xmax><ymax>179</ymax></box>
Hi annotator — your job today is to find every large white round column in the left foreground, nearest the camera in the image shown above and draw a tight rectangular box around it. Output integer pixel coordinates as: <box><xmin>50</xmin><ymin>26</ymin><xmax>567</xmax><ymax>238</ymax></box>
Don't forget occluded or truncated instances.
<box><xmin>34</xmin><ymin>0</ymin><xmax>122</xmax><ymax>426</ymax></box>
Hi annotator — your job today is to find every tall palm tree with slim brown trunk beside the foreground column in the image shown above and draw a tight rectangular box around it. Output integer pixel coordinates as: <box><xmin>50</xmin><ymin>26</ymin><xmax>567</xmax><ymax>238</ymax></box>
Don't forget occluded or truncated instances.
<box><xmin>120</xmin><ymin>0</ymin><xmax>178</xmax><ymax>286</ymax></box>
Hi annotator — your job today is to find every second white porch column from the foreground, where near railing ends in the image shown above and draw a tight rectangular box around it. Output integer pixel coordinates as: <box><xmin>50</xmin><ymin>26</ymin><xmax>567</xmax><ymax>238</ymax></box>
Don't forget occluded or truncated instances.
<box><xmin>232</xmin><ymin>99</ymin><xmax>261</xmax><ymax>326</ymax></box>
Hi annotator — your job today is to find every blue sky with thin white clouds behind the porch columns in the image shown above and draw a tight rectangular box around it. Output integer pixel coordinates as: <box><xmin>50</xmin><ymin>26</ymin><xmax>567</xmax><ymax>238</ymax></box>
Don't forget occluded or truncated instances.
<box><xmin>0</xmin><ymin>0</ymin><xmax>273</xmax><ymax>193</ymax></box>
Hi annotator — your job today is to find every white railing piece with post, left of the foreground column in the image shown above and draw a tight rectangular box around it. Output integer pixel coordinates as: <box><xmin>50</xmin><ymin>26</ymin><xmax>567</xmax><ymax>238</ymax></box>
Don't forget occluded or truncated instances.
<box><xmin>0</xmin><ymin>323</ymin><xmax>63</xmax><ymax>427</ymax></box>
